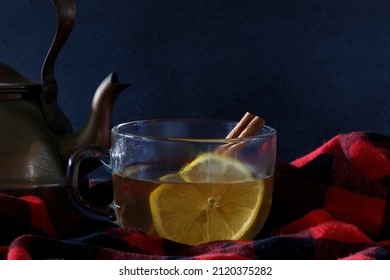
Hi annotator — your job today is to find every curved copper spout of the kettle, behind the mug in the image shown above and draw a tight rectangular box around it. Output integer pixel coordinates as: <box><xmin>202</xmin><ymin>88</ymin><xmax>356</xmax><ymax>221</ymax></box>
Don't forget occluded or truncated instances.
<box><xmin>60</xmin><ymin>72</ymin><xmax>131</xmax><ymax>160</ymax></box>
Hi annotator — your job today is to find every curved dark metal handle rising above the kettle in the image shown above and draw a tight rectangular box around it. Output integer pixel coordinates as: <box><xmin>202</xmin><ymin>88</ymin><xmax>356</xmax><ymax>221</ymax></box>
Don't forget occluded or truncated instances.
<box><xmin>41</xmin><ymin>0</ymin><xmax>76</xmax><ymax>133</ymax></box>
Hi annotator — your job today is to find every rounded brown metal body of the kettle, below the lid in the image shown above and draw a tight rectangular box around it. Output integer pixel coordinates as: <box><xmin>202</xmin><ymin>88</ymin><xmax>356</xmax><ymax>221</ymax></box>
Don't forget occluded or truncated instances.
<box><xmin>0</xmin><ymin>96</ymin><xmax>65</xmax><ymax>188</ymax></box>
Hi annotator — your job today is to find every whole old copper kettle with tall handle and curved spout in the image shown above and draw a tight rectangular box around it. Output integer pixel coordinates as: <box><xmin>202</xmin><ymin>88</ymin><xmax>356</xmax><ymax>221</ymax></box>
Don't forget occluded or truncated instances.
<box><xmin>0</xmin><ymin>0</ymin><xmax>130</xmax><ymax>188</ymax></box>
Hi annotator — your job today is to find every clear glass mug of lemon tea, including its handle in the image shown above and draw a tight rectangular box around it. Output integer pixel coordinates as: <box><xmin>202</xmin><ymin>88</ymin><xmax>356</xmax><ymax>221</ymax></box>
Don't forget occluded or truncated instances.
<box><xmin>67</xmin><ymin>120</ymin><xmax>276</xmax><ymax>245</ymax></box>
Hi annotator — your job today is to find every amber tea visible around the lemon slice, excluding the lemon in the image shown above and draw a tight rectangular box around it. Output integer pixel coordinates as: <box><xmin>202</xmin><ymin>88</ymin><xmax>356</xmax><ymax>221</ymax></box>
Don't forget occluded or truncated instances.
<box><xmin>113</xmin><ymin>165</ymin><xmax>273</xmax><ymax>238</ymax></box>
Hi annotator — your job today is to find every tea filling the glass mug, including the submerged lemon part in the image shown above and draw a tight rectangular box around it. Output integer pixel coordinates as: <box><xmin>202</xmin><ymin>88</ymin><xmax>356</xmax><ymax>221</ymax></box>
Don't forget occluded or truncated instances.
<box><xmin>113</xmin><ymin>159</ymin><xmax>273</xmax><ymax>245</ymax></box>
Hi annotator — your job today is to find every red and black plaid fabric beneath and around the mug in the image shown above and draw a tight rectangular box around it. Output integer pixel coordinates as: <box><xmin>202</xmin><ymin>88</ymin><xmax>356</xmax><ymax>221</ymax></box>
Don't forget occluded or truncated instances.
<box><xmin>0</xmin><ymin>132</ymin><xmax>390</xmax><ymax>259</ymax></box>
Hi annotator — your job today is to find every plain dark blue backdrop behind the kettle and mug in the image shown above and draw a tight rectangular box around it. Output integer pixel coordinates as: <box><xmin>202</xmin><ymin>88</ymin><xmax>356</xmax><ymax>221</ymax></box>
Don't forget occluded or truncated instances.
<box><xmin>0</xmin><ymin>0</ymin><xmax>390</xmax><ymax>160</ymax></box>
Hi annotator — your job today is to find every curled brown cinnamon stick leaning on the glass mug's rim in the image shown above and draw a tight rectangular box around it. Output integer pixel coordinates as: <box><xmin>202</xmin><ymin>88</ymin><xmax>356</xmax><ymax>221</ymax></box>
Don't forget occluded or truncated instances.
<box><xmin>215</xmin><ymin>112</ymin><xmax>265</xmax><ymax>155</ymax></box>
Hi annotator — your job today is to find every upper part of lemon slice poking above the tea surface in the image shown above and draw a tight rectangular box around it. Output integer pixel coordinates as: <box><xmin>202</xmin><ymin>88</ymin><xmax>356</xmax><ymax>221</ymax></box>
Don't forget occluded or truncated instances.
<box><xmin>179</xmin><ymin>153</ymin><xmax>252</xmax><ymax>183</ymax></box>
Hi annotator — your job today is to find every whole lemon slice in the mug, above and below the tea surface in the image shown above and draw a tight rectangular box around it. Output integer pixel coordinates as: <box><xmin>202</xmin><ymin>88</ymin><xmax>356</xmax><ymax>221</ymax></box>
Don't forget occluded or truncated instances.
<box><xmin>150</xmin><ymin>154</ymin><xmax>264</xmax><ymax>245</ymax></box>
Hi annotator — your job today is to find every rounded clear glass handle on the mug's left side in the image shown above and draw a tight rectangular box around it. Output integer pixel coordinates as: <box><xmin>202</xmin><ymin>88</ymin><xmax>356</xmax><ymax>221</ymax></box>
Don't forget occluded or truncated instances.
<box><xmin>66</xmin><ymin>145</ymin><xmax>117</xmax><ymax>223</ymax></box>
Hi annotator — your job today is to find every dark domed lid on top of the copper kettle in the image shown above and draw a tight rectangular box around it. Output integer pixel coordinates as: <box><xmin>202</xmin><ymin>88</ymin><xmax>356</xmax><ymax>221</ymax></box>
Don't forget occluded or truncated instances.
<box><xmin>0</xmin><ymin>62</ymin><xmax>42</xmax><ymax>94</ymax></box>
